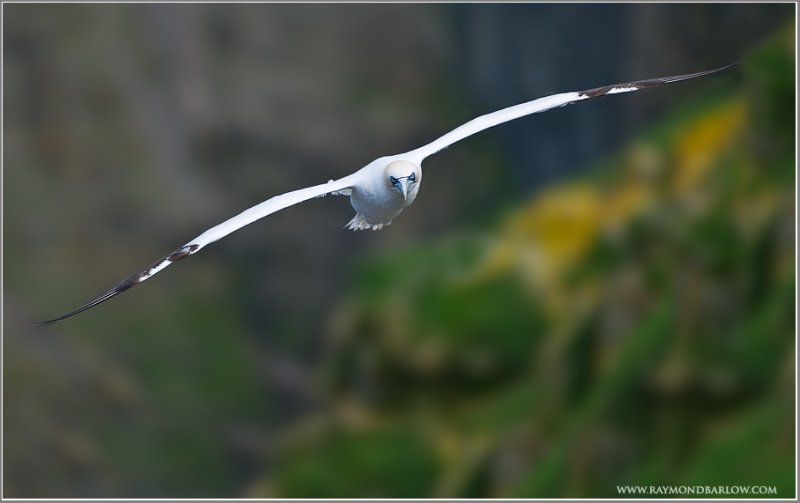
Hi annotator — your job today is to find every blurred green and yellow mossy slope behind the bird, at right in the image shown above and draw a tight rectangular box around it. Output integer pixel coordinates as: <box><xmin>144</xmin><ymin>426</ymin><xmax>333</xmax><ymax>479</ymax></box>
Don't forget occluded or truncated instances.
<box><xmin>255</xmin><ymin>26</ymin><xmax>796</xmax><ymax>497</ymax></box>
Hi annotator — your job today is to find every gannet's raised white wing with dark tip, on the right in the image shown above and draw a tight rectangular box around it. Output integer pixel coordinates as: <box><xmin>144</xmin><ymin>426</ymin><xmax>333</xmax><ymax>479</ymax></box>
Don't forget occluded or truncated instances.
<box><xmin>405</xmin><ymin>63</ymin><xmax>736</xmax><ymax>163</ymax></box>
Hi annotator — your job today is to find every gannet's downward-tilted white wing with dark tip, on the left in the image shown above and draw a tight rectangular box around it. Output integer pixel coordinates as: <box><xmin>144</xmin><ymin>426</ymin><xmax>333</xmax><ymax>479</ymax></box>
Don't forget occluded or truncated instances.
<box><xmin>39</xmin><ymin>174</ymin><xmax>356</xmax><ymax>327</ymax></box>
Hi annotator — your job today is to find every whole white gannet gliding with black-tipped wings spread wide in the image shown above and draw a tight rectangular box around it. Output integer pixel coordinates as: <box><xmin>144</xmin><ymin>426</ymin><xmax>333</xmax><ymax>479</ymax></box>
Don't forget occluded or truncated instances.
<box><xmin>40</xmin><ymin>65</ymin><xmax>733</xmax><ymax>326</ymax></box>
